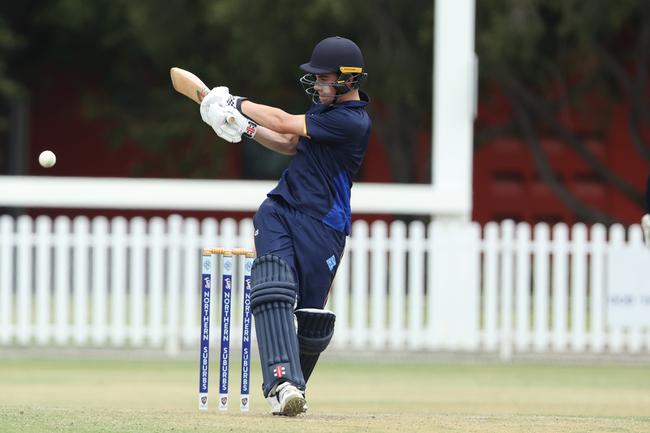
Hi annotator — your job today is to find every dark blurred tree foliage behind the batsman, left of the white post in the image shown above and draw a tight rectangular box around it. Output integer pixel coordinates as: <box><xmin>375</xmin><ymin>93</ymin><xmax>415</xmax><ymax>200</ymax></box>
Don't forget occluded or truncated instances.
<box><xmin>0</xmin><ymin>0</ymin><xmax>433</xmax><ymax>181</ymax></box>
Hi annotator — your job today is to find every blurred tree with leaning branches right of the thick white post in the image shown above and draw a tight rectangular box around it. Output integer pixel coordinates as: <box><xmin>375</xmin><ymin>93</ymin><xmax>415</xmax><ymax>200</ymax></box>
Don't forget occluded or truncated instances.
<box><xmin>476</xmin><ymin>0</ymin><xmax>650</xmax><ymax>223</ymax></box>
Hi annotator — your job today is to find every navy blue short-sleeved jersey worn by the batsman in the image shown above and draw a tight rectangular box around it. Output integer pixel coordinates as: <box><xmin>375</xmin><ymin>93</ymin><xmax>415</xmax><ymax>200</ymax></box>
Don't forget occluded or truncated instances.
<box><xmin>268</xmin><ymin>92</ymin><xmax>371</xmax><ymax>235</ymax></box>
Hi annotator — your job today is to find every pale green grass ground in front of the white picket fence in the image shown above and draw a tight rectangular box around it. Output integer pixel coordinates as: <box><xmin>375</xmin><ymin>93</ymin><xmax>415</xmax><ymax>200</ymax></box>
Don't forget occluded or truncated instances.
<box><xmin>0</xmin><ymin>352</ymin><xmax>650</xmax><ymax>433</ymax></box>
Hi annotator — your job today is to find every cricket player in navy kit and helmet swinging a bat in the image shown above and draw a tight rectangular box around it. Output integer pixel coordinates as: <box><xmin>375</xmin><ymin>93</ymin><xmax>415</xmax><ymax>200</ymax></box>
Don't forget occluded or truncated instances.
<box><xmin>201</xmin><ymin>36</ymin><xmax>371</xmax><ymax>416</ymax></box>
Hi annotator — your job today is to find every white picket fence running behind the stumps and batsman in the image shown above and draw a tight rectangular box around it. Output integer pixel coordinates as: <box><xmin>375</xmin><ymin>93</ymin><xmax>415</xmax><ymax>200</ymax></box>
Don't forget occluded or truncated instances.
<box><xmin>0</xmin><ymin>215</ymin><xmax>650</xmax><ymax>358</ymax></box>
